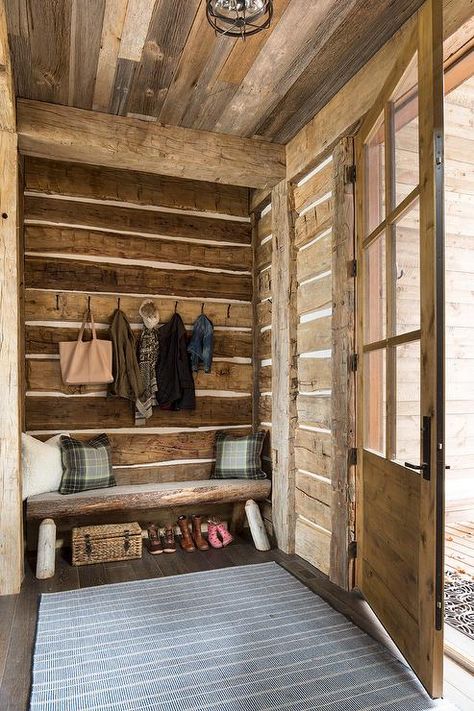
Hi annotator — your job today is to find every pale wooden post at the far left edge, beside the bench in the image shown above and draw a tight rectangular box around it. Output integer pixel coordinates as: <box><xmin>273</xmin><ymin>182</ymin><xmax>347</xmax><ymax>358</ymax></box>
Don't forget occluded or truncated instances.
<box><xmin>0</xmin><ymin>0</ymin><xmax>23</xmax><ymax>595</ymax></box>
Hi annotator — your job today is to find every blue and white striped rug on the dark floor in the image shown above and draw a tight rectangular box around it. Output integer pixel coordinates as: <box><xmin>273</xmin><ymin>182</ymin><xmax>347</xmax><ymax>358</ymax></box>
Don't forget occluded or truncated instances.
<box><xmin>31</xmin><ymin>563</ymin><xmax>454</xmax><ymax>711</ymax></box>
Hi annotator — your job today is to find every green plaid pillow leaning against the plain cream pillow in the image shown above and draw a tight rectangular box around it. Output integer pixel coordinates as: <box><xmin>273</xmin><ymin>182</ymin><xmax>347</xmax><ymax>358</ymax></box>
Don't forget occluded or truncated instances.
<box><xmin>59</xmin><ymin>434</ymin><xmax>116</xmax><ymax>494</ymax></box>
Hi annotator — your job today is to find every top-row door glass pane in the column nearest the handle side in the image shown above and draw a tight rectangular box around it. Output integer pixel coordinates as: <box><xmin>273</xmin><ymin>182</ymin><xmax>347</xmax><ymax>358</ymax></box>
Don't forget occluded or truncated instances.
<box><xmin>392</xmin><ymin>55</ymin><xmax>419</xmax><ymax>207</ymax></box>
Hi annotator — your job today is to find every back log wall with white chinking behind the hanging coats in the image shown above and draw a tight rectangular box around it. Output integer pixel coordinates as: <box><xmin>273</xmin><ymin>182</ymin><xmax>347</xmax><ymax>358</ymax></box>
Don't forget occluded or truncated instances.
<box><xmin>24</xmin><ymin>157</ymin><xmax>252</xmax><ymax>536</ymax></box>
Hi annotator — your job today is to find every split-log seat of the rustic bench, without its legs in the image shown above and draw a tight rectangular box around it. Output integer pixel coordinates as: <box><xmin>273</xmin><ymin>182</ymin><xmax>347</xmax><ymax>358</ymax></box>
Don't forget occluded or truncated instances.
<box><xmin>26</xmin><ymin>479</ymin><xmax>271</xmax><ymax>520</ymax></box>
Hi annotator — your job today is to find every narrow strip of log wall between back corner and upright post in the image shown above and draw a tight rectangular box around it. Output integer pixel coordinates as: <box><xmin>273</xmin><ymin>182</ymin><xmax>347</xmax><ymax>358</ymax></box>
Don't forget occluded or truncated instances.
<box><xmin>252</xmin><ymin>200</ymin><xmax>273</xmax><ymax>535</ymax></box>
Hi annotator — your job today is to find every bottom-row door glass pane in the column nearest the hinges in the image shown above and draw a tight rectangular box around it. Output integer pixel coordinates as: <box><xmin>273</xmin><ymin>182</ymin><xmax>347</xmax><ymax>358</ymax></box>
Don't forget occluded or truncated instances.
<box><xmin>364</xmin><ymin>349</ymin><xmax>386</xmax><ymax>456</ymax></box>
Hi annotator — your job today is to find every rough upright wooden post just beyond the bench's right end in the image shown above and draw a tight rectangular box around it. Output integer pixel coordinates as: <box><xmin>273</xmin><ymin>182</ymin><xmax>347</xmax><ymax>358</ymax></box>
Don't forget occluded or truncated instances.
<box><xmin>272</xmin><ymin>180</ymin><xmax>297</xmax><ymax>553</ymax></box>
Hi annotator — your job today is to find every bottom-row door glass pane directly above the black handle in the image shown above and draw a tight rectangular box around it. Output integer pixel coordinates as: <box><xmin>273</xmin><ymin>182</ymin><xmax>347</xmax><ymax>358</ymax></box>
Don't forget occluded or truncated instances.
<box><xmin>395</xmin><ymin>341</ymin><xmax>421</xmax><ymax>464</ymax></box>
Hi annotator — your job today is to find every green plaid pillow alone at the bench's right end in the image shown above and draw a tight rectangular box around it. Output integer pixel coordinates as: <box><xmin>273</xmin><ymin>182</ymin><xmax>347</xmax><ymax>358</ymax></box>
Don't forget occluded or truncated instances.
<box><xmin>211</xmin><ymin>432</ymin><xmax>266</xmax><ymax>479</ymax></box>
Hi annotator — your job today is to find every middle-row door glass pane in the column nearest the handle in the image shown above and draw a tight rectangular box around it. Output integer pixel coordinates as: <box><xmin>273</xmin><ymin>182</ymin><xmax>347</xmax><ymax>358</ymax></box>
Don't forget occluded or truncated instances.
<box><xmin>392</xmin><ymin>200</ymin><xmax>420</xmax><ymax>335</ymax></box>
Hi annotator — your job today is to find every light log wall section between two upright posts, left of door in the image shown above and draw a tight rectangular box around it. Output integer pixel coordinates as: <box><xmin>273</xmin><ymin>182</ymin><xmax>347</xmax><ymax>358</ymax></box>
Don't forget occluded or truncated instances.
<box><xmin>294</xmin><ymin>156</ymin><xmax>334</xmax><ymax>574</ymax></box>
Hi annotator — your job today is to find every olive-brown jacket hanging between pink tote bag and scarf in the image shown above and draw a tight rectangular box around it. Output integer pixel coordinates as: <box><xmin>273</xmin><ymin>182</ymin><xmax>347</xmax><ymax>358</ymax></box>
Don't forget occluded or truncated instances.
<box><xmin>108</xmin><ymin>309</ymin><xmax>144</xmax><ymax>402</ymax></box>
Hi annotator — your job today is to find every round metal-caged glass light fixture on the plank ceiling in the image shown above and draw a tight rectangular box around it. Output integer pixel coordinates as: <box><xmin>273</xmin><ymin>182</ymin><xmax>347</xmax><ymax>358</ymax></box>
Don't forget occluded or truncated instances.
<box><xmin>206</xmin><ymin>0</ymin><xmax>273</xmax><ymax>39</ymax></box>
